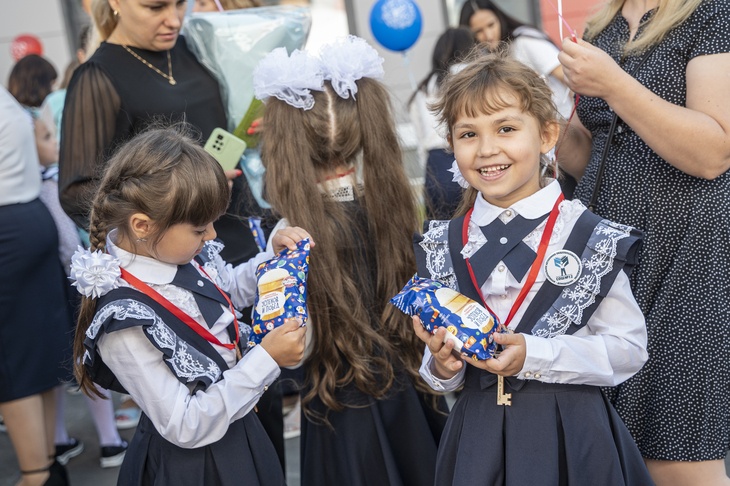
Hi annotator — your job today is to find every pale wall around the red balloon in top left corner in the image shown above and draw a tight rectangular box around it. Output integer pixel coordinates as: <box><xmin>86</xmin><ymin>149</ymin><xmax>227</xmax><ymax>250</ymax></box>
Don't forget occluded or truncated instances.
<box><xmin>0</xmin><ymin>0</ymin><xmax>71</xmax><ymax>86</ymax></box>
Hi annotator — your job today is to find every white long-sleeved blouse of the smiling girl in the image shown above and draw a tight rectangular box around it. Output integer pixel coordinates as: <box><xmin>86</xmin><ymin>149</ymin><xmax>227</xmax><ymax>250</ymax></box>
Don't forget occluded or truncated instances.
<box><xmin>420</xmin><ymin>181</ymin><xmax>648</xmax><ymax>391</ymax></box>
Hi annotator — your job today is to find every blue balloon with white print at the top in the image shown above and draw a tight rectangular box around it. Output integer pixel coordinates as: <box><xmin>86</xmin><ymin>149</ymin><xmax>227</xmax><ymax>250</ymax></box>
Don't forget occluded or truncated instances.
<box><xmin>370</xmin><ymin>0</ymin><xmax>422</xmax><ymax>52</ymax></box>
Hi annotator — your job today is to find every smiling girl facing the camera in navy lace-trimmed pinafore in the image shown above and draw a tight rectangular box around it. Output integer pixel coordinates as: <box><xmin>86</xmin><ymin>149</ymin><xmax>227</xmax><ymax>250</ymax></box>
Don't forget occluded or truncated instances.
<box><xmin>414</xmin><ymin>53</ymin><xmax>651</xmax><ymax>486</ymax></box>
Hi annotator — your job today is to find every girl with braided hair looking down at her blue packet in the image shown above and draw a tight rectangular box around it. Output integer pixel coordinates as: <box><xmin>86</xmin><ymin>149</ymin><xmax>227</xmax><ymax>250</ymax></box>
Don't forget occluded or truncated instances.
<box><xmin>71</xmin><ymin>129</ymin><xmax>309</xmax><ymax>486</ymax></box>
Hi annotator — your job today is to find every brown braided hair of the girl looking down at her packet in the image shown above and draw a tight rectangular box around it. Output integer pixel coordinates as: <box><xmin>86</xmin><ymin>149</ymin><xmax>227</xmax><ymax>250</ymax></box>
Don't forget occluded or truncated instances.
<box><xmin>74</xmin><ymin>124</ymin><xmax>230</xmax><ymax>395</ymax></box>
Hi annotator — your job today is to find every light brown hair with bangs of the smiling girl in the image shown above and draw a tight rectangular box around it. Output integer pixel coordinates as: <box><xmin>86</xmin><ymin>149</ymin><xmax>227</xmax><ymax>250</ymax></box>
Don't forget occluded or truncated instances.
<box><xmin>430</xmin><ymin>47</ymin><xmax>558</xmax><ymax>216</ymax></box>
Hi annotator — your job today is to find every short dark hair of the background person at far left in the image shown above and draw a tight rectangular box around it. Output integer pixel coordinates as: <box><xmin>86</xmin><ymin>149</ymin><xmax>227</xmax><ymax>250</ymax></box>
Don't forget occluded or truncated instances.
<box><xmin>8</xmin><ymin>54</ymin><xmax>58</xmax><ymax>108</ymax></box>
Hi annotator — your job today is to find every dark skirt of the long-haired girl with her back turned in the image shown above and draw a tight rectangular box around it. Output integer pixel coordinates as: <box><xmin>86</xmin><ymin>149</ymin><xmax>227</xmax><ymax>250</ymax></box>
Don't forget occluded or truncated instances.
<box><xmin>301</xmin><ymin>378</ymin><xmax>447</xmax><ymax>486</ymax></box>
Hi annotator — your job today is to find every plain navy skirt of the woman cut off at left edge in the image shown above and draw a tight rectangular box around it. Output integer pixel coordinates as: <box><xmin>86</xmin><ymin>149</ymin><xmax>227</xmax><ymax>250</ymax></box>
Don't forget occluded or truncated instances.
<box><xmin>0</xmin><ymin>199</ymin><xmax>74</xmax><ymax>402</ymax></box>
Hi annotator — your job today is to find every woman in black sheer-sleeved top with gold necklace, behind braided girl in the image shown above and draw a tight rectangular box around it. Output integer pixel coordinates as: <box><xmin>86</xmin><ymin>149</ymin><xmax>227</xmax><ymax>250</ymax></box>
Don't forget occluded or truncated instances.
<box><xmin>59</xmin><ymin>0</ymin><xmax>258</xmax><ymax>265</ymax></box>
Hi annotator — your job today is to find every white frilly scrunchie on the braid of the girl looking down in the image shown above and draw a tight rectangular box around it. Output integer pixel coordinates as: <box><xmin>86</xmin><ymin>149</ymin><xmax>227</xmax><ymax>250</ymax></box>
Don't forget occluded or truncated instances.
<box><xmin>68</xmin><ymin>247</ymin><xmax>122</xmax><ymax>299</ymax></box>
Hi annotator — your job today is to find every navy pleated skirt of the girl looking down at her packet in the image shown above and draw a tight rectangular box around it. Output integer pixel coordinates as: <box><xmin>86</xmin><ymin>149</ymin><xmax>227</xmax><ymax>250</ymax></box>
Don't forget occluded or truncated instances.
<box><xmin>117</xmin><ymin>412</ymin><xmax>285</xmax><ymax>486</ymax></box>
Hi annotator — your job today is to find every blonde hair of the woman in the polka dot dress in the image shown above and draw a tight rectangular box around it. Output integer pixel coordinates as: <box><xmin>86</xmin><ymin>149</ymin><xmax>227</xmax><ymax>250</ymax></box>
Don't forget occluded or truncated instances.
<box><xmin>584</xmin><ymin>0</ymin><xmax>703</xmax><ymax>54</ymax></box>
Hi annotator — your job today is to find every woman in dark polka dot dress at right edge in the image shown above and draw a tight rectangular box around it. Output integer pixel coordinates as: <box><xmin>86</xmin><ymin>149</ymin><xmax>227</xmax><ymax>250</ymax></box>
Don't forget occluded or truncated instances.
<box><xmin>560</xmin><ymin>0</ymin><xmax>730</xmax><ymax>485</ymax></box>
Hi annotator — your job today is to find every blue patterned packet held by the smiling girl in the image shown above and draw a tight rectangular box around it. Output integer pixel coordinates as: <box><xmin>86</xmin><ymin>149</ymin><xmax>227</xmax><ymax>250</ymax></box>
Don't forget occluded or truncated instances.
<box><xmin>390</xmin><ymin>275</ymin><xmax>505</xmax><ymax>361</ymax></box>
